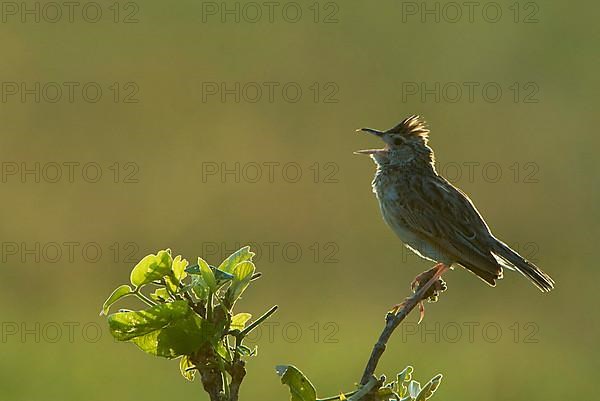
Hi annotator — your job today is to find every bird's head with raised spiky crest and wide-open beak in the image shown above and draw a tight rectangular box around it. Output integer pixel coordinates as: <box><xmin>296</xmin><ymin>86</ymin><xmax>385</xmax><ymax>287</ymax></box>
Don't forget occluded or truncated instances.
<box><xmin>354</xmin><ymin>115</ymin><xmax>433</xmax><ymax>166</ymax></box>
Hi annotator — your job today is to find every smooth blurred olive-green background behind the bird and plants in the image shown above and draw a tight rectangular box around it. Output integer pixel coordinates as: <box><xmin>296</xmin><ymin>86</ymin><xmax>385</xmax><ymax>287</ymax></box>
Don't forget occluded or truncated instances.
<box><xmin>0</xmin><ymin>0</ymin><xmax>600</xmax><ymax>401</ymax></box>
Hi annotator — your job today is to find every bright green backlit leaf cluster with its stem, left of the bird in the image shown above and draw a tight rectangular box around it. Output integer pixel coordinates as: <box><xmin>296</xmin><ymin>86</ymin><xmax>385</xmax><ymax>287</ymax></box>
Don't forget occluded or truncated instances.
<box><xmin>101</xmin><ymin>247</ymin><xmax>277</xmax><ymax>392</ymax></box>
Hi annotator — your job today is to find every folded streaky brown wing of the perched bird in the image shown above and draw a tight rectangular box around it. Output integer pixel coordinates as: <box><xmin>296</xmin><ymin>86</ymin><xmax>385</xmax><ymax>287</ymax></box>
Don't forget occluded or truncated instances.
<box><xmin>391</xmin><ymin>175</ymin><xmax>502</xmax><ymax>285</ymax></box>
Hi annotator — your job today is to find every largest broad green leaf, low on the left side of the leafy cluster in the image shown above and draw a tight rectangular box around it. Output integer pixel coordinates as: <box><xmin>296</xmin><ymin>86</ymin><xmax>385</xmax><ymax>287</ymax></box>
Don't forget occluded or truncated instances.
<box><xmin>108</xmin><ymin>301</ymin><xmax>215</xmax><ymax>358</ymax></box>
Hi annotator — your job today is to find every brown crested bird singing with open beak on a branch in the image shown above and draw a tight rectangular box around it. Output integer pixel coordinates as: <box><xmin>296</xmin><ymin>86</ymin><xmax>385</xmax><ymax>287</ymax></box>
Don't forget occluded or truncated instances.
<box><xmin>354</xmin><ymin>115</ymin><xmax>555</xmax><ymax>306</ymax></box>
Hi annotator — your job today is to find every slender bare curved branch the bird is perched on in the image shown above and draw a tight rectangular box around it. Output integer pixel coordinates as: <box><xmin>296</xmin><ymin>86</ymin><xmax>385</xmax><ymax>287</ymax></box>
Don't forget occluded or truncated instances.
<box><xmin>360</xmin><ymin>268</ymin><xmax>445</xmax><ymax>386</ymax></box>
